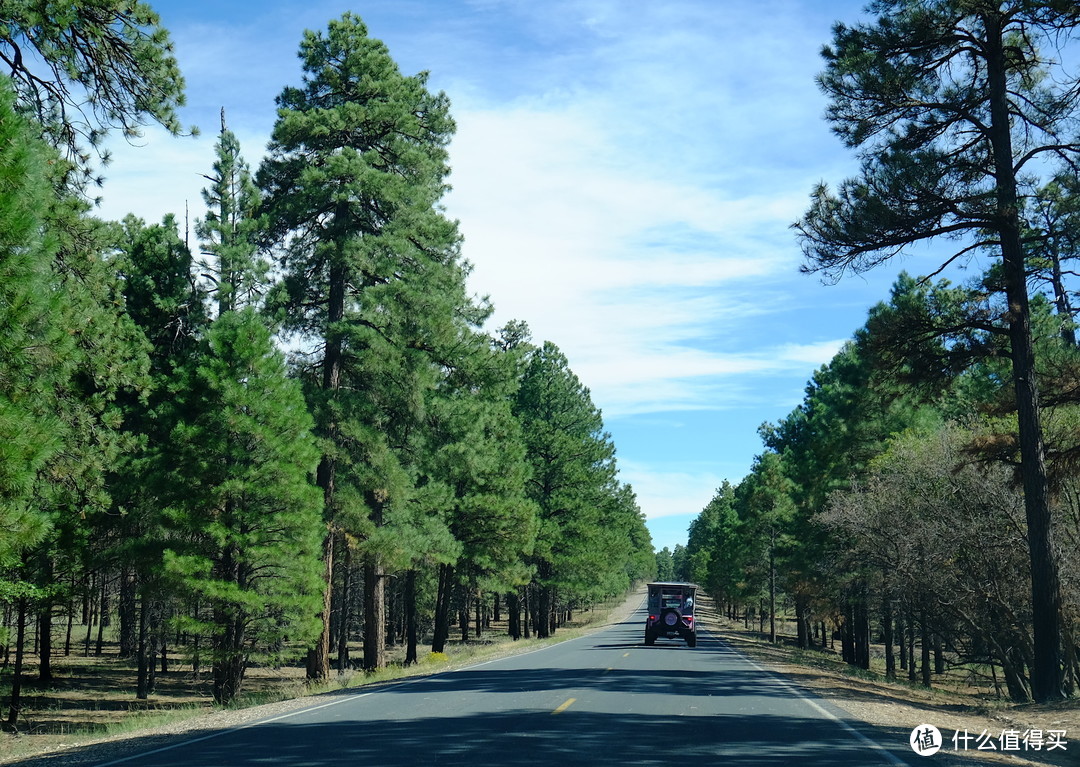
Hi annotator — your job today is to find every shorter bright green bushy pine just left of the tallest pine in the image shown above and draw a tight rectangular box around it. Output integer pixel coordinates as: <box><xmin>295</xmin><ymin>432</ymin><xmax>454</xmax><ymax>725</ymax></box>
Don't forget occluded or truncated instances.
<box><xmin>164</xmin><ymin>309</ymin><xmax>322</xmax><ymax>703</ymax></box>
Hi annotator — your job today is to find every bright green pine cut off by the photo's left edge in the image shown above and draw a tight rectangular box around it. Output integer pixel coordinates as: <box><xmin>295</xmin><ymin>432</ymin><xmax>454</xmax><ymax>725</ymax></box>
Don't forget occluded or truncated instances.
<box><xmin>0</xmin><ymin>73</ymin><xmax>152</xmax><ymax>726</ymax></box>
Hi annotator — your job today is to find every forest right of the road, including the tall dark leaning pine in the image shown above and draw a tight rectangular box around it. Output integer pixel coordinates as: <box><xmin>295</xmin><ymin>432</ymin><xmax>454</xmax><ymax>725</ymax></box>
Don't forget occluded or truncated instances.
<box><xmin>661</xmin><ymin>1</ymin><xmax>1080</xmax><ymax>702</ymax></box>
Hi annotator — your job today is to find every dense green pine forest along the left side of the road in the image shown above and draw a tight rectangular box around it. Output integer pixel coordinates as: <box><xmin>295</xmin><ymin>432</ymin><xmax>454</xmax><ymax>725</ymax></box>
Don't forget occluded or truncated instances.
<box><xmin>0</xmin><ymin>0</ymin><xmax>654</xmax><ymax>730</ymax></box>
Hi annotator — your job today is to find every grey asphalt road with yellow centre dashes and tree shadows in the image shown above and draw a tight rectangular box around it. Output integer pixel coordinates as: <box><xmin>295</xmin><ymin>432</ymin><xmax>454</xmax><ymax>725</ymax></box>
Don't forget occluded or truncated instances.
<box><xmin>82</xmin><ymin>609</ymin><xmax>920</xmax><ymax>767</ymax></box>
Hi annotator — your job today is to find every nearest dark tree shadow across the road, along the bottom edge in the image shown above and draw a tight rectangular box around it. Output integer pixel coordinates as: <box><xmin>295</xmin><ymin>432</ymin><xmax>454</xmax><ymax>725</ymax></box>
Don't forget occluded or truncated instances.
<box><xmin>4</xmin><ymin>709</ymin><xmax>937</xmax><ymax>767</ymax></box>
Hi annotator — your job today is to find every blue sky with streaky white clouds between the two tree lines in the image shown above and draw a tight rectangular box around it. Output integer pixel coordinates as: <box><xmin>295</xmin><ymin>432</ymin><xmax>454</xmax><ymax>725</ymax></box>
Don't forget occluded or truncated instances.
<box><xmin>100</xmin><ymin>0</ymin><xmax>920</xmax><ymax>549</ymax></box>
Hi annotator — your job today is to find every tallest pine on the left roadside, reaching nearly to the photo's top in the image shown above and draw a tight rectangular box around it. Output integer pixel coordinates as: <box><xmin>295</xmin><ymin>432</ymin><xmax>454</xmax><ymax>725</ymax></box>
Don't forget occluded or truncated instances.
<box><xmin>258</xmin><ymin>14</ymin><xmax>468</xmax><ymax>678</ymax></box>
